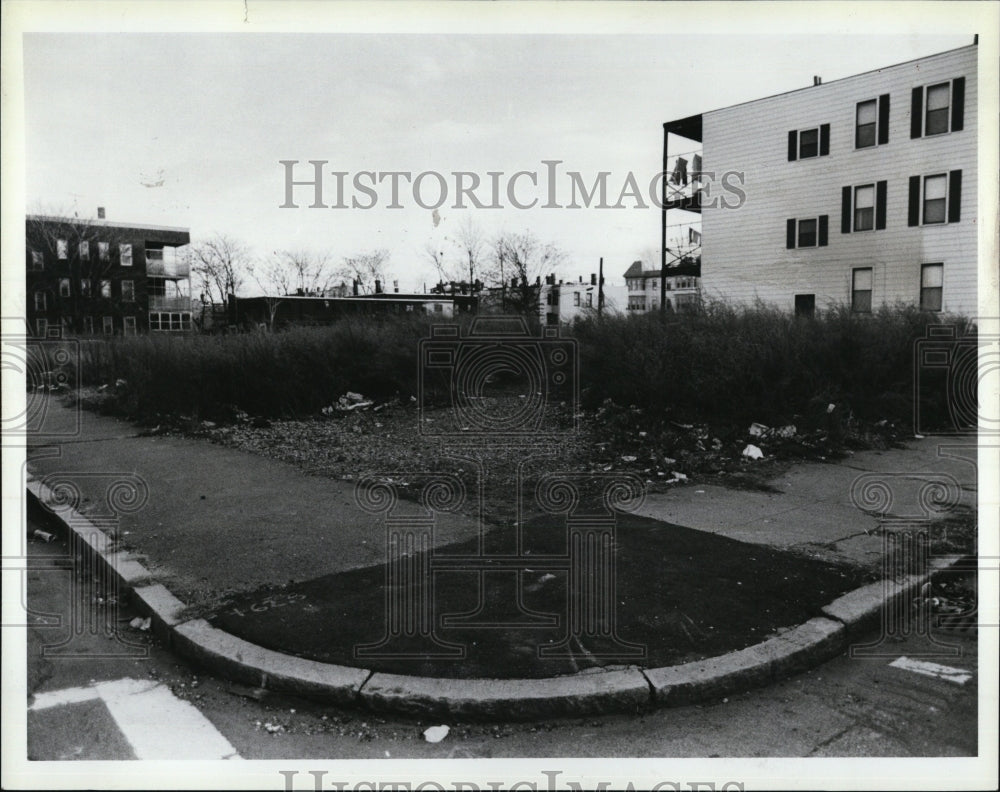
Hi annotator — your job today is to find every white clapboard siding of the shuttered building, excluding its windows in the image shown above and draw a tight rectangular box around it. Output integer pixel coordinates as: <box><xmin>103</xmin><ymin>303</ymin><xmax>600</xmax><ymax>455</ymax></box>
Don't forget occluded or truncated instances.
<box><xmin>702</xmin><ymin>46</ymin><xmax>978</xmax><ymax>315</ymax></box>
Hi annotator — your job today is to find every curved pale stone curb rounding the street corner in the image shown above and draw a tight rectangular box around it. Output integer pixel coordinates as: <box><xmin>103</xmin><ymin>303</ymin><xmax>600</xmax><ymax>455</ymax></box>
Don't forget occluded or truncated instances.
<box><xmin>26</xmin><ymin>474</ymin><xmax>959</xmax><ymax>720</ymax></box>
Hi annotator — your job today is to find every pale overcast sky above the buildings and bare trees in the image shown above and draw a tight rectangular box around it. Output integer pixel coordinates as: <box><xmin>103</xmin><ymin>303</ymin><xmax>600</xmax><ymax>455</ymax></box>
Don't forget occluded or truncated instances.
<box><xmin>24</xmin><ymin>30</ymin><xmax>972</xmax><ymax>291</ymax></box>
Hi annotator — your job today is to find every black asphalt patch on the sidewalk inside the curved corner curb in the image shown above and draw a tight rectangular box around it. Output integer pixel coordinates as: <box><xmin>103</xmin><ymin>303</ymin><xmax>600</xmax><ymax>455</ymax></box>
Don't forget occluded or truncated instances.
<box><xmin>208</xmin><ymin>515</ymin><xmax>866</xmax><ymax>678</ymax></box>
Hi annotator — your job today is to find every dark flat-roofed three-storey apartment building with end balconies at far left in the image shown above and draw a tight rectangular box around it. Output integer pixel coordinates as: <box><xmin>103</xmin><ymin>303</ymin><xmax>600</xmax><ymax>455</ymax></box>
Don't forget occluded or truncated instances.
<box><xmin>25</xmin><ymin>210</ymin><xmax>192</xmax><ymax>337</ymax></box>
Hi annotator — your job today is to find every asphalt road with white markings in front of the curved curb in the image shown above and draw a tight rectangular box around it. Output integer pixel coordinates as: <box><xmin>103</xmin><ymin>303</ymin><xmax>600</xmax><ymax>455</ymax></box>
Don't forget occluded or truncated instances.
<box><xmin>19</xmin><ymin>510</ymin><xmax>978</xmax><ymax>776</ymax></box>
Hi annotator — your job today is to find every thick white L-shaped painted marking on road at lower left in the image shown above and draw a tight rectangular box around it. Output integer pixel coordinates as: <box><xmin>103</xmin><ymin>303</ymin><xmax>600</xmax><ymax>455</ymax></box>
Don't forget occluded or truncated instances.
<box><xmin>28</xmin><ymin>679</ymin><xmax>240</xmax><ymax>759</ymax></box>
